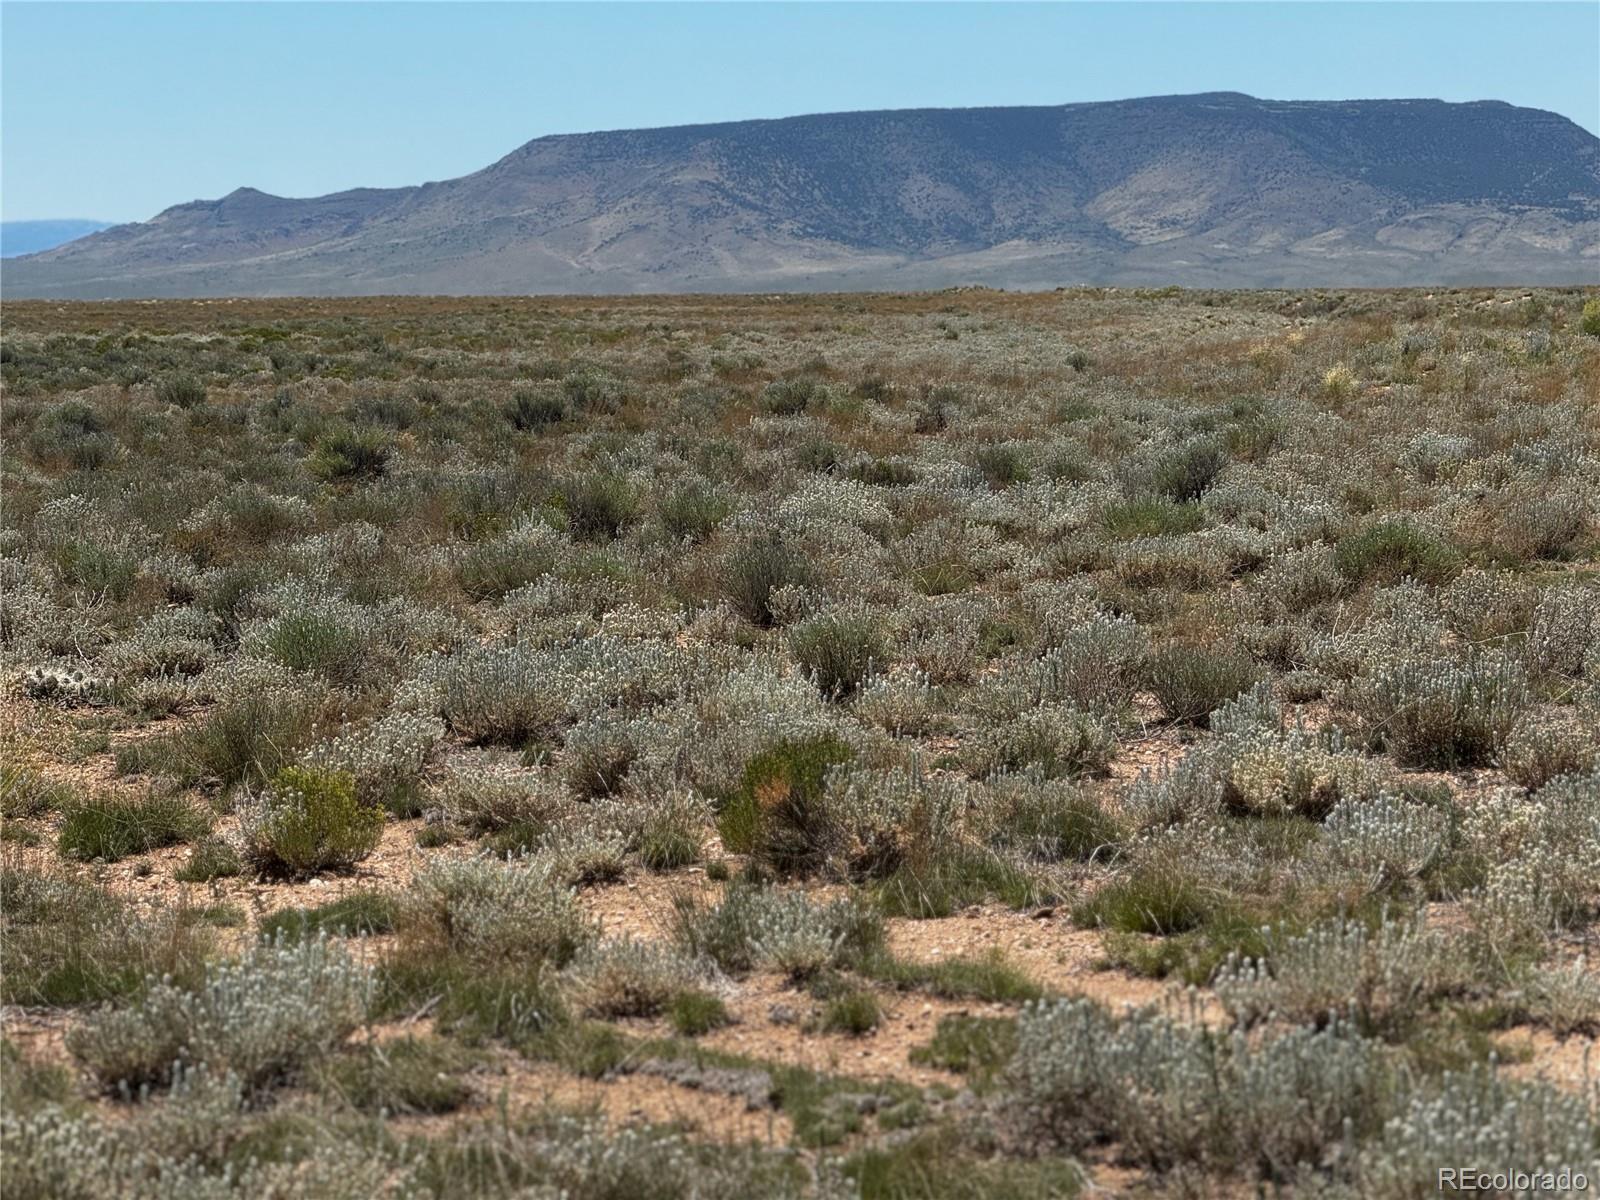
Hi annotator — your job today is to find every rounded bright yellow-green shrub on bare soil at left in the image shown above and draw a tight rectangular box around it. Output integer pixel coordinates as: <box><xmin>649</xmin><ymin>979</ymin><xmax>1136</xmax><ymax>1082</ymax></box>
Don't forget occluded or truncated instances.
<box><xmin>238</xmin><ymin>766</ymin><xmax>384</xmax><ymax>875</ymax></box>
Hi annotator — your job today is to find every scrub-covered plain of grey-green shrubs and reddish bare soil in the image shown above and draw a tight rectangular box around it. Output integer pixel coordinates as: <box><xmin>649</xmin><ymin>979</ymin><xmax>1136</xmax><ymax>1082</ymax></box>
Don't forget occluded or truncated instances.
<box><xmin>0</xmin><ymin>290</ymin><xmax>1600</xmax><ymax>1200</ymax></box>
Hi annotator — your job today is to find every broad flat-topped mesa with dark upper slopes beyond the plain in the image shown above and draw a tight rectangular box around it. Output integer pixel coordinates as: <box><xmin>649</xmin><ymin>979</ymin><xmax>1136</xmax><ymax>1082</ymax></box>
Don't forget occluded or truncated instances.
<box><xmin>3</xmin><ymin>93</ymin><xmax>1600</xmax><ymax>298</ymax></box>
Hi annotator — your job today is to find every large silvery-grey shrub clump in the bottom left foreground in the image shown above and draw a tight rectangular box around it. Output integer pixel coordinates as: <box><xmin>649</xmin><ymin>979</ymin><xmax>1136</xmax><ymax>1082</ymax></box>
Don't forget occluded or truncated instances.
<box><xmin>67</xmin><ymin>938</ymin><xmax>373</xmax><ymax>1088</ymax></box>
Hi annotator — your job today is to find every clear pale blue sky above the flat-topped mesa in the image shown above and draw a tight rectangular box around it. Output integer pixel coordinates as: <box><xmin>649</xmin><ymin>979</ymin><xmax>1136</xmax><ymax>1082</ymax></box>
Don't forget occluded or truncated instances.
<box><xmin>0</xmin><ymin>0</ymin><xmax>1600</xmax><ymax>221</ymax></box>
